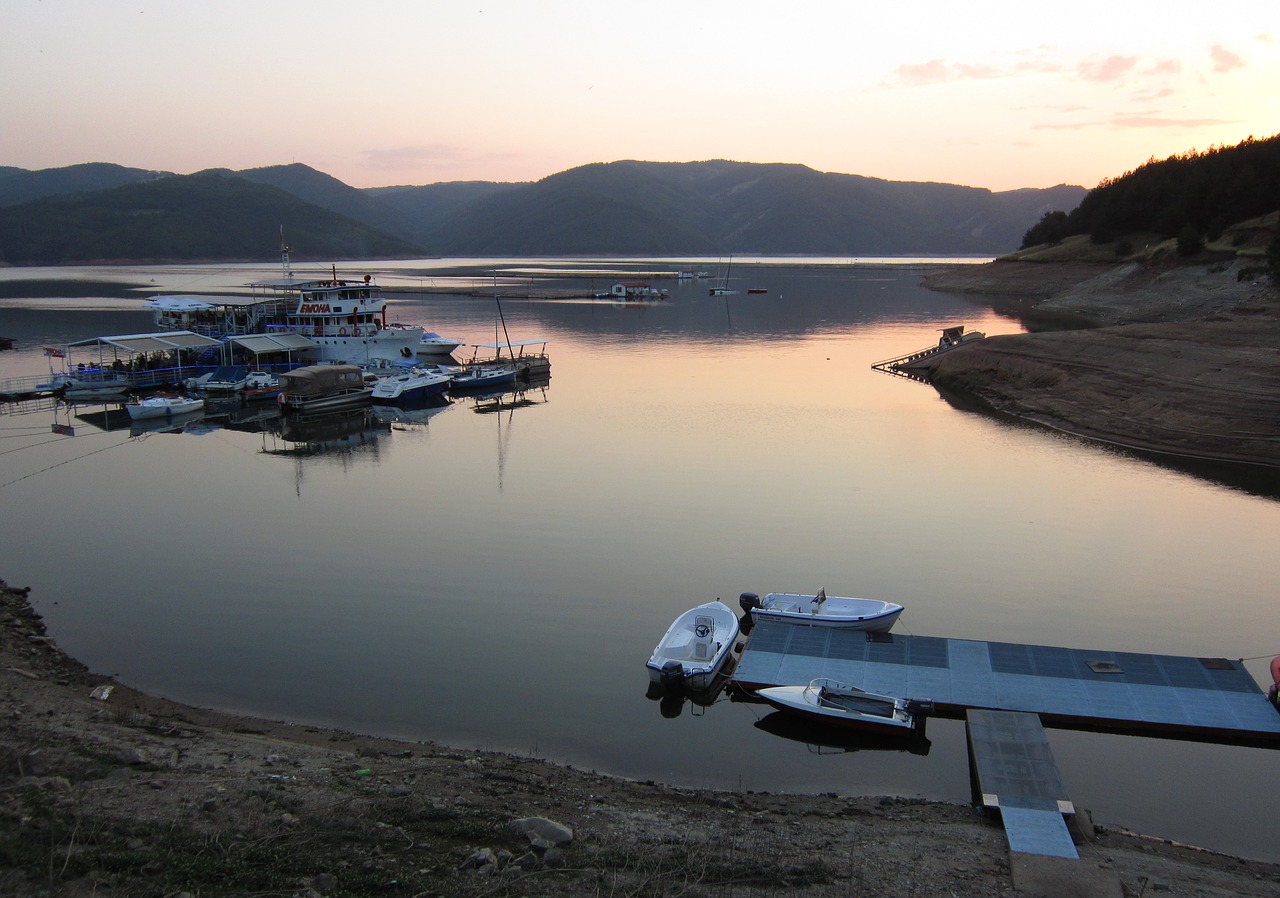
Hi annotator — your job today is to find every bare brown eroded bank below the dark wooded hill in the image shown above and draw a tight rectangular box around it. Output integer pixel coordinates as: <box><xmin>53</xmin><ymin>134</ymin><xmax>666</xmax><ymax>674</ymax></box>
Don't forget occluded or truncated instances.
<box><xmin>925</xmin><ymin>261</ymin><xmax>1280</xmax><ymax>466</ymax></box>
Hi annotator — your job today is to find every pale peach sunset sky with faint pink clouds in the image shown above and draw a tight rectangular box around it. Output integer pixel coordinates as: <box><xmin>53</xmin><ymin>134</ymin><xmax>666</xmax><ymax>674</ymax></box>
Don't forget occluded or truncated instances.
<box><xmin>0</xmin><ymin>0</ymin><xmax>1280</xmax><ymax>191</ymax></box>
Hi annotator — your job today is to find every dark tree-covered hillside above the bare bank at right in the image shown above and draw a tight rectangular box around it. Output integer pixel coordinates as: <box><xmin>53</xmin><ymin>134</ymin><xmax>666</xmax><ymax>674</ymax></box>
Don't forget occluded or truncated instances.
<box><xmin>1021</xmin><ymin>134</ymin><xmax>1280</xmax><ymax>248</ymax></box>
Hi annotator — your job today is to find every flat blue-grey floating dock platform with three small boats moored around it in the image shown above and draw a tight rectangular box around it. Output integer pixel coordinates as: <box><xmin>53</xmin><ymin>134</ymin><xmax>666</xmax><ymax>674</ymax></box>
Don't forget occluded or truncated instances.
<box><xmin>735</xmin><ymin>619</ymin><xmax>1280</xmax><ymax>747</ymax></box>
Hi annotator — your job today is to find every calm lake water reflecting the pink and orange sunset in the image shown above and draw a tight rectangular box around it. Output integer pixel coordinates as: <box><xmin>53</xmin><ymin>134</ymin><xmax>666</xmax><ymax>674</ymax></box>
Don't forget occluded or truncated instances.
<box><xmin>0</xmin><ymin>262</ymin><xmax>1280</xmax><ymax>860</ymax></box>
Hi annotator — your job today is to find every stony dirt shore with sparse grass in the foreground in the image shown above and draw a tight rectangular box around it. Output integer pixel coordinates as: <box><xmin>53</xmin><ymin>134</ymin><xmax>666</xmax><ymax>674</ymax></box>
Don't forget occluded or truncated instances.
<box><xmin>0</xmin><ymin>583</ymin><xmax>1280</xmax><ymax>898</ymax></box>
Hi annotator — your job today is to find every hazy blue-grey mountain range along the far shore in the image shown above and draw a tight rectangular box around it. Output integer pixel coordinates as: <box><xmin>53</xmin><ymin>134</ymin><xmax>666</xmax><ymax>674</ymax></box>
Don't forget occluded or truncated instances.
<box><xmin>0</xmin><ymin>160</ymin><xmax>1085</xmax><ymax>265</ymax></box>
